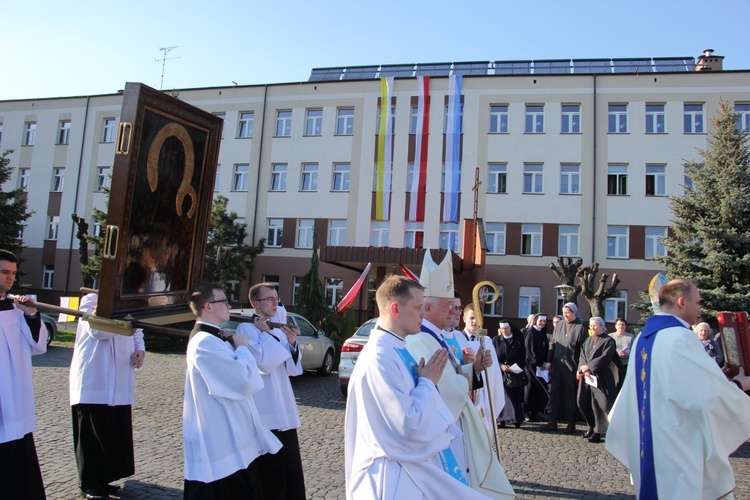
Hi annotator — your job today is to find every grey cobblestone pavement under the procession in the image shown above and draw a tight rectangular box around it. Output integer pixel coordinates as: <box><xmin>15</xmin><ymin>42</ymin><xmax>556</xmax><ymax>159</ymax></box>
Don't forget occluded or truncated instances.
<box><xmin>34</xmin><ymin>344</ymin><xmax>750</xmax><ymax>499</ymax></box>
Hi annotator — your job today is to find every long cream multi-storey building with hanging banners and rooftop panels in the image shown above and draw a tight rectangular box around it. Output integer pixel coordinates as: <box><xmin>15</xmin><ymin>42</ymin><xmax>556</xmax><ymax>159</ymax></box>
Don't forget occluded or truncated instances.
<box><xmin>0</xmin><ymin>51</ymin><xmax>750</xmax><ymax>326</ymax></box>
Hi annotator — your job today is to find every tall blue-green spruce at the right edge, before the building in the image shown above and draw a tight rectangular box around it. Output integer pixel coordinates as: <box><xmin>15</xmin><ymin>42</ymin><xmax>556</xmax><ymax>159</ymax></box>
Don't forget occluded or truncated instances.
<box><xmin>657</xmin><ymin>100</ymin><xmax>750</xmax><ymax>314</ymax></box>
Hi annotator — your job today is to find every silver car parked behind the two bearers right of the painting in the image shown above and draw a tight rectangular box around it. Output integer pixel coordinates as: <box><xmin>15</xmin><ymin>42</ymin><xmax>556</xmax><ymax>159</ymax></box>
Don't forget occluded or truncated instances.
<box><xmin>220</xmin><ymin>309</ymin><xmax>336</xmax><ymax>376</ymax></box>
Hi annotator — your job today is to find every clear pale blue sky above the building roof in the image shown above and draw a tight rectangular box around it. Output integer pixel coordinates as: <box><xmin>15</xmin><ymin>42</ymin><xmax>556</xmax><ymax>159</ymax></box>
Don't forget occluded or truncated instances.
<box><xmin>5</xmin><ymin>0</ymin><xmax>750</xmax><ymax>100</ymax></box>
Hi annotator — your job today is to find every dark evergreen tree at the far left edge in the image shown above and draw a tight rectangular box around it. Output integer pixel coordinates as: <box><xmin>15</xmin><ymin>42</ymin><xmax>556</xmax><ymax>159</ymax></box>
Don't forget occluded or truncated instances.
<box><xmin>0</xmin><ymin>149</ymin><xmax>34</xmax><ymax>286</ymax></box>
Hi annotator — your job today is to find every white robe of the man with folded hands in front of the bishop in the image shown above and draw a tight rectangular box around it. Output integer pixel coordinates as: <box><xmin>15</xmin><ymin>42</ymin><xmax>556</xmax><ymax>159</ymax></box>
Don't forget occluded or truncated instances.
<box><xmin>345</xmin><ymin>328</ymin><xmax>485</xmax><ymax>500</ymax></box>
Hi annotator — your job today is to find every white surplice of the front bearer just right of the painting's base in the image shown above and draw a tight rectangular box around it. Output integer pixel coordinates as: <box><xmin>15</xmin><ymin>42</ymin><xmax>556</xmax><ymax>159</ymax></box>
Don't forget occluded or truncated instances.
<box><xmin>182</xmin><ymin>326</ymin><xmax>281</xmax><ymax>483</ymax></box>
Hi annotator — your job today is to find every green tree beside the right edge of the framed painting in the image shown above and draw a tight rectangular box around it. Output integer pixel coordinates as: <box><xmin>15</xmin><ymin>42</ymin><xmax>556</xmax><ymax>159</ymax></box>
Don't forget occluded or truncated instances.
<box><xmin>203</xmin><ymin>196</ymin><xmax>266</xmax><ymax>297</ymax></box>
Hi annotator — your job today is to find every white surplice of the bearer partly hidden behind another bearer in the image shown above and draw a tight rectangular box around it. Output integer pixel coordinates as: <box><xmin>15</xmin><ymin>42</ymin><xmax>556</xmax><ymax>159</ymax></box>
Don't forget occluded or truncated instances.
<box><xmin>237</xmin><ymin>323</ymin><xmax>302</xmax><ymax>431</ymax></box>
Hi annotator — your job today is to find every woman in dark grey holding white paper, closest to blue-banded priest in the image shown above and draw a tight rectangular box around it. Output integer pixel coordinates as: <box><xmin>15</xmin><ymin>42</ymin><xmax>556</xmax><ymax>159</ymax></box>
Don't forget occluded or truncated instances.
<box><xmin>577</xmin><ymin>316</ymin><xmax>623</xmax><ymax>443</ymax></box>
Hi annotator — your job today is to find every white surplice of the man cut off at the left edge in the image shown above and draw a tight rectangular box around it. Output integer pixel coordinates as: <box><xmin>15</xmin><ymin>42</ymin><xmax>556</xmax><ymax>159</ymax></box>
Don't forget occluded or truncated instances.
<box><xmin>0</xmin><ymin>305</ymin><xmax>47</xmax><ymax>443</ymax></box>
